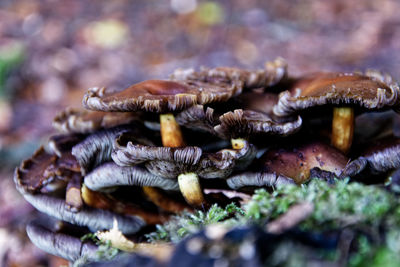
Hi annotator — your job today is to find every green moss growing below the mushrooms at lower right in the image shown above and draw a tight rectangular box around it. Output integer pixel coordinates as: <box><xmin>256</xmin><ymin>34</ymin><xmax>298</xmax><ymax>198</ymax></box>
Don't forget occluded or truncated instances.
<box><xmin>147</xmin><ymin>179</ymin><xmax>400</xmax><ymax>266</ymax></box>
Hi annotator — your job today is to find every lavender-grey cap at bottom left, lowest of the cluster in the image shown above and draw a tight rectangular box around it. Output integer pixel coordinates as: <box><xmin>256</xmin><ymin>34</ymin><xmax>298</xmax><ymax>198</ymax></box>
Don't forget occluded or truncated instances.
<box><xmin>26</xmin><ymin>221</ymin><xmax>98</xmax><ymax>262</ymax></box>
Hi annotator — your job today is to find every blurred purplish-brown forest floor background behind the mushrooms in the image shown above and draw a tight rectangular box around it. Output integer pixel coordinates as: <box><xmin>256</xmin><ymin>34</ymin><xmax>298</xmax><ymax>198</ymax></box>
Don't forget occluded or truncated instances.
<box><xmin>0</xmin><ymin>0</ymin><xmax>400</xmax><ymax>266</ymax></box>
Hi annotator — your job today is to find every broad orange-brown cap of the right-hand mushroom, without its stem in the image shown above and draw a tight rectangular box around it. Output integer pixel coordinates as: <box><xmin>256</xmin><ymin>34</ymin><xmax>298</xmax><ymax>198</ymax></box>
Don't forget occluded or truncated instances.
<box><xmin>273</xmin><ymin>72</ymin><xmax>400</xmax><ymax>116</ymax></box>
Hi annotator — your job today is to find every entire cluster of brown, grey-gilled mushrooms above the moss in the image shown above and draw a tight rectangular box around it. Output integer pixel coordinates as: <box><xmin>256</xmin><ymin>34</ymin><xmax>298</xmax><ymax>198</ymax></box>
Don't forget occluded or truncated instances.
<box><xmin>14</xmin><ymin>59</ymin><xmax>400</xmax><ymax>261</ymax></box>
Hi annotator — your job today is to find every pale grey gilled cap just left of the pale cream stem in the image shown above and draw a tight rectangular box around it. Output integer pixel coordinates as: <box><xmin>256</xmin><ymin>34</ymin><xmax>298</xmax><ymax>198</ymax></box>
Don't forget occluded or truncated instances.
<box><xmin>84</xmin><ymin>162</ymin><xmax>179</xmax><ymax>191</ymax></box>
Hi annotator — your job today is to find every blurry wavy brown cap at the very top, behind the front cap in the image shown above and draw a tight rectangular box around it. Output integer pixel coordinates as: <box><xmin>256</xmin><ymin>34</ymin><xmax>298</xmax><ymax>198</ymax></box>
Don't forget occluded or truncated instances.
<box><xmin>171</xmin><ymin>58</ymin><xmax>287</xmax><ymax>88</ymax></box>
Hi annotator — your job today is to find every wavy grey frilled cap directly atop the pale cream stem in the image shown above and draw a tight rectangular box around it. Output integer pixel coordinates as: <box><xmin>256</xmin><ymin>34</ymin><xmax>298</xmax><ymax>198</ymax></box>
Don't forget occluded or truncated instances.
<box><xmin>112</xmin><ymin>134</ymin><xmax>256</xmax><ymax>178</ymax></box>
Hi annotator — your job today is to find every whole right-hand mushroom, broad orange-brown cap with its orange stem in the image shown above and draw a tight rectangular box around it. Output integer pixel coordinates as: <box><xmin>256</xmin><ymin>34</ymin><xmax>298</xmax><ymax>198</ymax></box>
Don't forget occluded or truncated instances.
<box><xmin>273</xmin><ymin>71</ymin><xmax>400</xmax><ymax>153</ymax></box>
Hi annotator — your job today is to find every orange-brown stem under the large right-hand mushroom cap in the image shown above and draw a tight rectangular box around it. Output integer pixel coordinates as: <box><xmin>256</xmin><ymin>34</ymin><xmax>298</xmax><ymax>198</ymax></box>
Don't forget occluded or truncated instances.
<box><xmin>331</xmin><ymin>107</ymin><xmax>354</xmax><ymax>153</ymax></box>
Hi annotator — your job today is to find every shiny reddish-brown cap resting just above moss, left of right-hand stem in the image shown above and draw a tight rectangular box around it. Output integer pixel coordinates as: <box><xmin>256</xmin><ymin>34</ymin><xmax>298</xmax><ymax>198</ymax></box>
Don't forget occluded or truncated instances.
<box><xmin>260</xmin><ymin>142</ymin><xmax>348</xmax><ymax>183</ymax></box>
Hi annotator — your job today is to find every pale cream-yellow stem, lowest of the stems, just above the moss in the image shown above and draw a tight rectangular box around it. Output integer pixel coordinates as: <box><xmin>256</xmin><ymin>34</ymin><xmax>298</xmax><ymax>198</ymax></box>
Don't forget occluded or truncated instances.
<box><xmin>178</xmin><ymin>172</ymin><xmax>205</xmax><ymax>206</ymax></box>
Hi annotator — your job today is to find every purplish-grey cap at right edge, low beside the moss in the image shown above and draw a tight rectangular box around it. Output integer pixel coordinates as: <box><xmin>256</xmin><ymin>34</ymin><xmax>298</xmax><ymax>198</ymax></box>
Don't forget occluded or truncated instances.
<box><xmin>342</xmin><ymin>137</ymin><xmax>400</xmax><ymax>176</ymax></box>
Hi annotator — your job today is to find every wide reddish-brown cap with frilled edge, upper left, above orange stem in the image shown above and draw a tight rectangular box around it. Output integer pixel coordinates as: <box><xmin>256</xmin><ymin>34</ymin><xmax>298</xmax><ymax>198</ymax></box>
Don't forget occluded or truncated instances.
<box><xmin>83</xmin><ymin>80</ymin><xmax>242</xmax><ymax>113</ymax></box>
